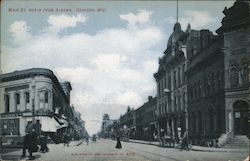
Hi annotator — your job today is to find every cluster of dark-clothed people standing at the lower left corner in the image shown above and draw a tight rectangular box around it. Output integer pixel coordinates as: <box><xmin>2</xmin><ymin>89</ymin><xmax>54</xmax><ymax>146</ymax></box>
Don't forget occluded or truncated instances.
<box><xmin>22</xmin><ymin>129</ymin><xmax>49</xmax><ymax>159</ymax></box>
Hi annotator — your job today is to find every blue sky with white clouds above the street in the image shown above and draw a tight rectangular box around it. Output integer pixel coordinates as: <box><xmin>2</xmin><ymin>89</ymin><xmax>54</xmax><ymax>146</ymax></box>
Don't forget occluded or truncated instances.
<box><xmin>1</xmin><ymin>0</ymin><xmax>234</xmax><ymax>134</ymax></box>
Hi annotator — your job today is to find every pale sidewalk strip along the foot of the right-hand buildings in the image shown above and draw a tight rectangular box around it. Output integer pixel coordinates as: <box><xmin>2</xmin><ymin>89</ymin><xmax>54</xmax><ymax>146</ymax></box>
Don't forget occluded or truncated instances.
<box><xmin>129</xmin><ymin>139</ymin><xmax>249</xmax><ymax>152</ymax></box>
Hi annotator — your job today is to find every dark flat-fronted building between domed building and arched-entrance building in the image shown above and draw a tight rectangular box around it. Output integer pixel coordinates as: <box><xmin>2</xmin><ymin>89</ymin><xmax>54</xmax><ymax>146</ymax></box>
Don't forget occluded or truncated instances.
<box><xmin>186</xmin><ymin>30</ymin><xmax>225</xmax><ymax>144</ymax></box>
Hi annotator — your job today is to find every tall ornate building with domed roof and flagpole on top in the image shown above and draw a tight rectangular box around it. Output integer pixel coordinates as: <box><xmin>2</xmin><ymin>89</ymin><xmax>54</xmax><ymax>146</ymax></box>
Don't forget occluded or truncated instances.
<box><xmin>154</xmin><ymin>22</ymin><xmax>190</xmax><ymax>141</ymax></box>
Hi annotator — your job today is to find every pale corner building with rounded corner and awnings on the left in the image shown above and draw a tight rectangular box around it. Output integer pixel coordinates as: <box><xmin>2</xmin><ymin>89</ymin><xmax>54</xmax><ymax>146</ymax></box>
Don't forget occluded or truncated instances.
<box><xmin>0</xmin><ymin>68</ymin><xmax>71</xmax><ymax>144</ymax></box>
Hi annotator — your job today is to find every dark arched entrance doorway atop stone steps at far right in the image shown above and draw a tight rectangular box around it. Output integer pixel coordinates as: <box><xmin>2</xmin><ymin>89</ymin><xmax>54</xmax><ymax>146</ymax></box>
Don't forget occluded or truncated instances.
<box><xmin>233</xmin><ymin>101</ymin><xmax>249</xmax><ymax>135</ymax></box>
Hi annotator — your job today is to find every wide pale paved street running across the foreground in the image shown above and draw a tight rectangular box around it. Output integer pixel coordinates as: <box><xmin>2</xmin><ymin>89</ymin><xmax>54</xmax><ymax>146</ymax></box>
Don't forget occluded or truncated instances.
<box><xmin>1</xmin><ymin>139</ymin><xmax>248</xmax><ymax>161</ymax></box>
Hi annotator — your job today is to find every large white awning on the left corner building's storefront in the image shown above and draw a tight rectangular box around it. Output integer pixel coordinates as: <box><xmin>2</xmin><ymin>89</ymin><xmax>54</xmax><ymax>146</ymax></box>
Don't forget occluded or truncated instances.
<box><xmin>36</xmin><ymin>116</ymin><xmax>60</xmax><ymax>132</ymax></box>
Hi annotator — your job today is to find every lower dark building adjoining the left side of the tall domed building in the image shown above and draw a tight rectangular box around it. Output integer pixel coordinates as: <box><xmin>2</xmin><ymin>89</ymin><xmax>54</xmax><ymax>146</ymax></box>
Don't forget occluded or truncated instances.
<box><xmin>135</xmin><ymin>96</ymin><xmax>157</xmax><ymax>141</ymax></box>
